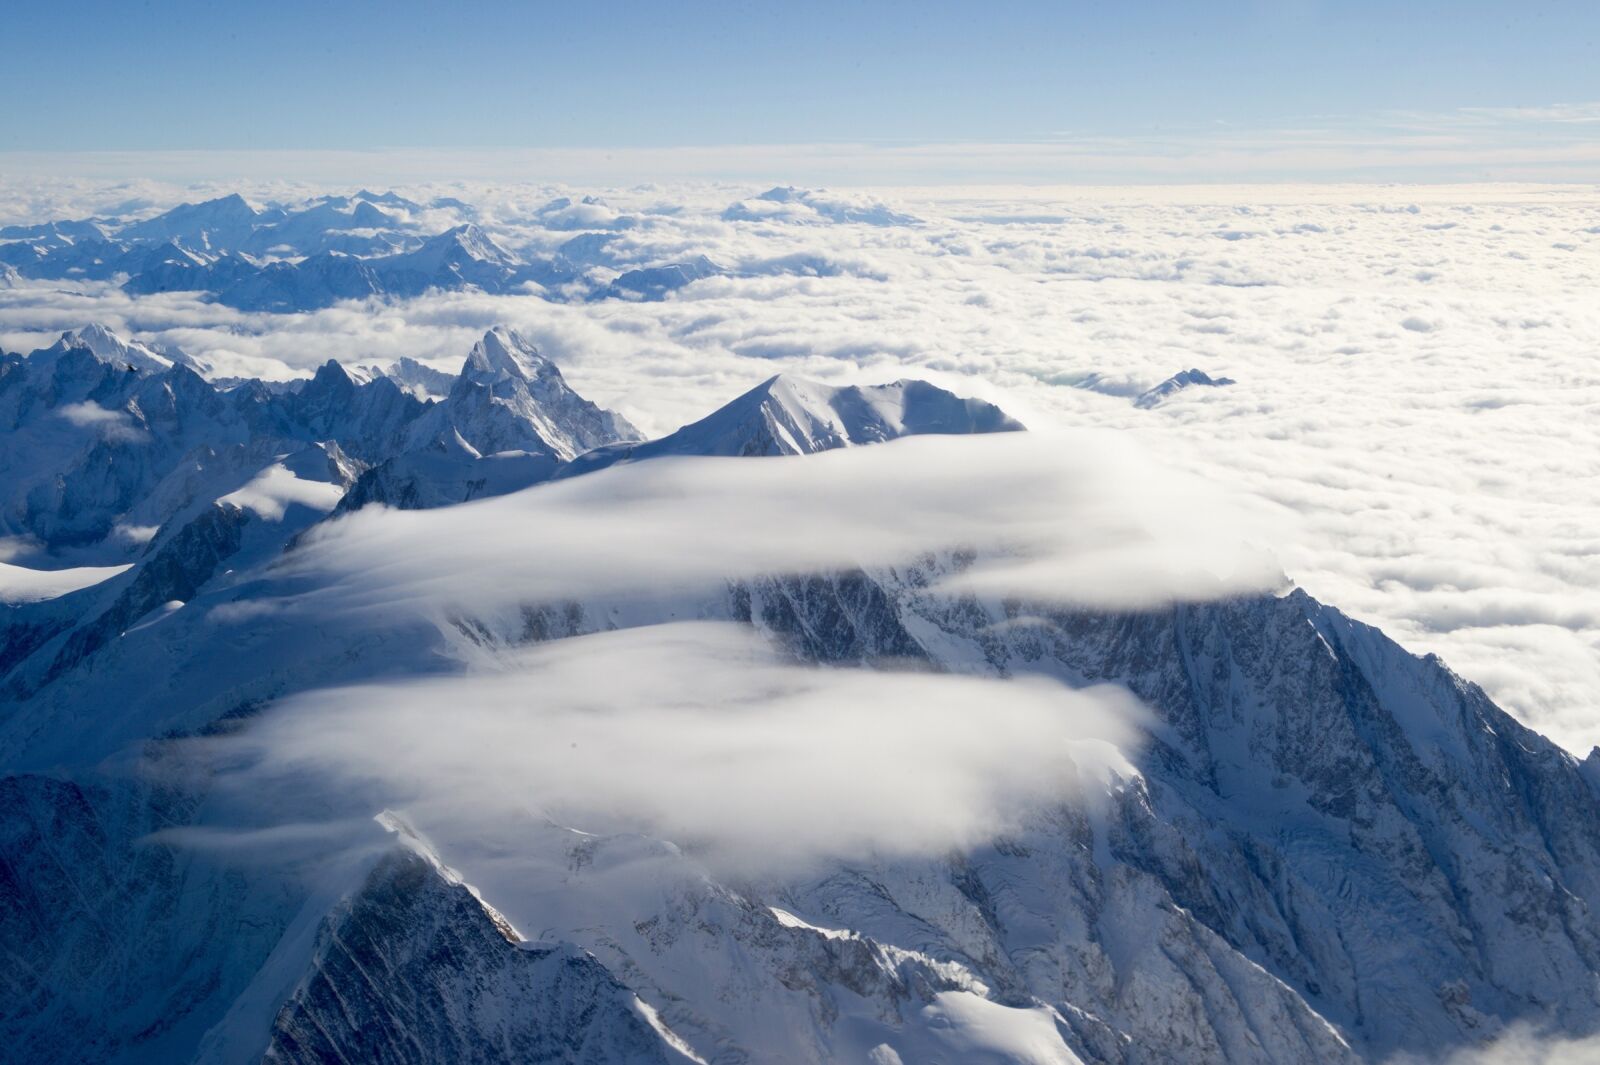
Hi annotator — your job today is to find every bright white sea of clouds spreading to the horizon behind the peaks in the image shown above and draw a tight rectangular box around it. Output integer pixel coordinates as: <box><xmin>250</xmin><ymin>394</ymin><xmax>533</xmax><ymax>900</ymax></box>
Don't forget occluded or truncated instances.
<box><xmin>0</xmin><ymin>181</ymin><xmax>1600</xmax><ymax>752</ymax></box>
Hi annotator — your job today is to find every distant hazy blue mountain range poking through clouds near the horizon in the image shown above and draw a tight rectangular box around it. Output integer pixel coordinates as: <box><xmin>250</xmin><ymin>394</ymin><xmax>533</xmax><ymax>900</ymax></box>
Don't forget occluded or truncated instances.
<box><xmin>0</xmin><ymin>189</ymin><xmax>915</xmax><ymax>313</ymax></box>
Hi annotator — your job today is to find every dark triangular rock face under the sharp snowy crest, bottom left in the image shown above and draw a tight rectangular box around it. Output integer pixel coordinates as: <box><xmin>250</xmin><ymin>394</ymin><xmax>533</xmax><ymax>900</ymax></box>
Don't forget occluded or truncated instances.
<box><xmin>262</xmin><ymin>849</ymin><xmax>694</xmax><ymax>1065</ymax></box>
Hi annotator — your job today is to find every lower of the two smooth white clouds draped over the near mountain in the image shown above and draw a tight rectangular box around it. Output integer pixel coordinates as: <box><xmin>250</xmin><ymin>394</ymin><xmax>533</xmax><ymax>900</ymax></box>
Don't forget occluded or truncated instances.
<box><xmin>225</xmin><ymin>622</ymin><xmax>1144</xmax><ymax>873</ymax></box>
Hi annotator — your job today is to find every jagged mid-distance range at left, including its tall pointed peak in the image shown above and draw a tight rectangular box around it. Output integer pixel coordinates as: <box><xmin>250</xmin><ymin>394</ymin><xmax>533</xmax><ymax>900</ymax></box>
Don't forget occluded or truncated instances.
<box><xmin>0</xmin><ymin>325</ymin><xmax>640</xmax><ymax>561</ymax></box>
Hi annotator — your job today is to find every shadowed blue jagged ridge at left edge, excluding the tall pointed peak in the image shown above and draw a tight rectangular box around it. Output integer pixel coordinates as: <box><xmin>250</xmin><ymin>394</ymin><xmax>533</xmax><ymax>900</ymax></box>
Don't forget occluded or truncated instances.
<box><xmin>0</xmin><ymin>326</ymin><xmax>387</xmax><ymax>556</ymax></box>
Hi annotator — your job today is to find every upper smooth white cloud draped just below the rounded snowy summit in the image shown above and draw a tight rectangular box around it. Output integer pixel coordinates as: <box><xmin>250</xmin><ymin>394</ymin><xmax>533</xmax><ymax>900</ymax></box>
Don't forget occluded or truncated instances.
<box><xmin>282</xmin><ymin>432</ymin><xmax>1282</xmax><ymax>617</ymax></box>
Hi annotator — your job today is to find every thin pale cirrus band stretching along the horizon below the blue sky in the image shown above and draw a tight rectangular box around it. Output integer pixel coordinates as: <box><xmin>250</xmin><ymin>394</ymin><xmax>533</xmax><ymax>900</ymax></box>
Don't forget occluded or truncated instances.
<box><xmin>0</xmin><ymin>101</ymin><xmax>1600</xmax><ymax>182</ymax></box>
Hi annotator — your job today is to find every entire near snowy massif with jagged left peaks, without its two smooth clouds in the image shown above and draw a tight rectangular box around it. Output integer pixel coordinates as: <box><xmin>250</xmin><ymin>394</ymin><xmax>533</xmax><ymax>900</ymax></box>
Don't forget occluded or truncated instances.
<box><xmin>0</xmin><ymin>329</ymin><xmax>1600</xmax><ymax>1065</ymax></box>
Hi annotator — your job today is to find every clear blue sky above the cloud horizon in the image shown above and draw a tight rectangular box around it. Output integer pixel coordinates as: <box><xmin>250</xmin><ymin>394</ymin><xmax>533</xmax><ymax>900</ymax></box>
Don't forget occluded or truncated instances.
<box><xmin>0</xmin><ymin>0</ymin><xmax>1600</xmax><ymax>178</ymax></box>
